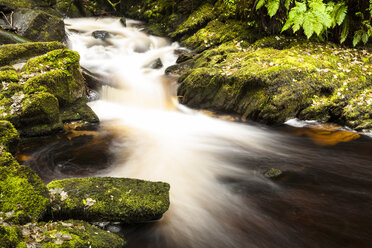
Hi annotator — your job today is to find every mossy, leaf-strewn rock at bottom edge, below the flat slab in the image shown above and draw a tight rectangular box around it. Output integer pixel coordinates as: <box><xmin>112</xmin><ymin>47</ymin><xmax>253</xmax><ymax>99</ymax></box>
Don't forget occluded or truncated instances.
<box><xmin>14</xmin><ymin>220</ymin><xmax>125</xmax><ymax>248</ymax></box>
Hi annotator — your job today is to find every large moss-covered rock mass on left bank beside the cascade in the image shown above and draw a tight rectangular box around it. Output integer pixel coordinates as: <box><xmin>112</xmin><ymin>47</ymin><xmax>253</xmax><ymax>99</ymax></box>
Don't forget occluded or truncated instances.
<box><xmin>0</xmin><ymin>42</ymin><xmax>98</xmax><ymax>136</ymax></box>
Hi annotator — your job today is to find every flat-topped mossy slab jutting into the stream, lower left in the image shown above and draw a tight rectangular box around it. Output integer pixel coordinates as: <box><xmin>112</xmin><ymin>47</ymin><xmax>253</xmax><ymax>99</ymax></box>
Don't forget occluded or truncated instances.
<box><xmin>47</xmin><ymin>177</ymin><xmax>169</xmax><ymax>223</ymax></box>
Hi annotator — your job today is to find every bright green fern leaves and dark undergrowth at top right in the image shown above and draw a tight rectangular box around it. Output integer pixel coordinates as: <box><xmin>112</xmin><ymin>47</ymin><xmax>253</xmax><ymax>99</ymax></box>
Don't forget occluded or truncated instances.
<box><xmin>224</xmin><ymin>0</ymin><xmax>372</xmax><ymax>46</ymax></box>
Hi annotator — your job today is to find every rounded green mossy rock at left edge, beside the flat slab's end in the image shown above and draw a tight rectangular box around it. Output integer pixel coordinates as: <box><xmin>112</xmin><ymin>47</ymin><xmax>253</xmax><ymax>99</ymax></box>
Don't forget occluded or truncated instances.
<box><xmin>0</xmin><ymin>166</ymin><xmax>49</xmax><ymax>224</ymax></box>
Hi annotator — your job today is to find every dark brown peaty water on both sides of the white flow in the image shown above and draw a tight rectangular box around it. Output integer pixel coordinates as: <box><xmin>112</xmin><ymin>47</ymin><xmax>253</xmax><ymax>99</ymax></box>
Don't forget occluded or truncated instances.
<box><xmin>18</xmin><ymin>123</ymin><xmax>372</xmax><ymax>248</ymax></box>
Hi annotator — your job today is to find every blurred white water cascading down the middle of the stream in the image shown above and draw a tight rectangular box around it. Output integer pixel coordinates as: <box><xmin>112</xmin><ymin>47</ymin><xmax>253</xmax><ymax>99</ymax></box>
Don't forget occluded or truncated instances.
<box><xmin>65</xmin><ymin>18</ymin><xmax>288</xmax><ymax>247</ymax></box>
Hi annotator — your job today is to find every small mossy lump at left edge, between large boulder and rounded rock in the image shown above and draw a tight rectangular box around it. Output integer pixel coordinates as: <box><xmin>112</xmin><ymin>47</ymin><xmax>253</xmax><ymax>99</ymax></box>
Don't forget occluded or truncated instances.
<box><xmin>0</xmin><ymin>121</ymin><xmax>19</xmax><ymax>153</ymax></box>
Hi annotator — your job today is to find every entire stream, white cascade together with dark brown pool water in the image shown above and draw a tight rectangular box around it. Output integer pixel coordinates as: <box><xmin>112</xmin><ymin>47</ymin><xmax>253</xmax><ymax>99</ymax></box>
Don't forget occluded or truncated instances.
<box><xmin>19</xmin><ymin>18</ymin><xmax>372</xmax><ymax>248</ymax></box>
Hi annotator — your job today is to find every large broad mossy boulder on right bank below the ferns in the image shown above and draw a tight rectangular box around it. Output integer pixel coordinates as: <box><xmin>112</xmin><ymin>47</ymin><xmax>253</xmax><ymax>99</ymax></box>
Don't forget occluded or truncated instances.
<box><xmin>178</xmin><ymin>37</ymin><xmax>372</xmax><ymax>130</ymax></box>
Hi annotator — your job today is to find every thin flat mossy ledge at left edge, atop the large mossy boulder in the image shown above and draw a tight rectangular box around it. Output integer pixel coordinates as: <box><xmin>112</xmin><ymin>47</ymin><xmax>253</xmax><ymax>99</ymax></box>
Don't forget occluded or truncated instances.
<box><xmin>0</xmin><ymin>42</ymin><xmax>65</xmax><ymax>66</ymax></box>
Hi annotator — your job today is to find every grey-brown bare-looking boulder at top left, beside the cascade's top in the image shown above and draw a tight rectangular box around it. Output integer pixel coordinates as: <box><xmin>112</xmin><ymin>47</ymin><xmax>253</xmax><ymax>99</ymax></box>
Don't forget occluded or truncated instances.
<box><xmin>13</xmin><ymin>8</ymin><xmax>65</xmax><ymax>41</ymax></box>
